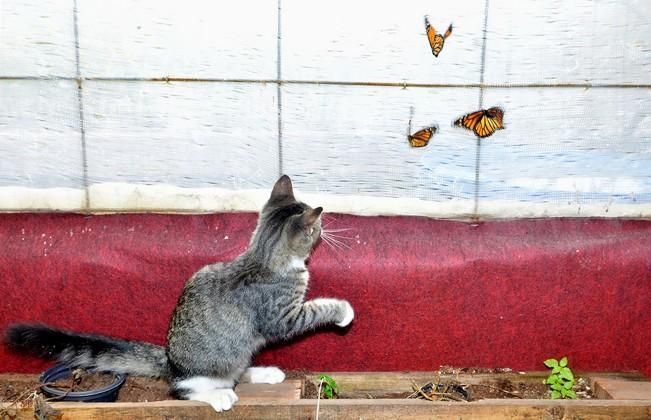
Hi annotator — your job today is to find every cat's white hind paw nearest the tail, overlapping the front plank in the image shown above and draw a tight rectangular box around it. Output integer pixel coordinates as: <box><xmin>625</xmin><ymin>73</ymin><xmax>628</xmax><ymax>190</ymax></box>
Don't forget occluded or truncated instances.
<box><xmin>172</xmin><ymin>376</ymin><xmax>238</xmax><ymax>411</ymax></box>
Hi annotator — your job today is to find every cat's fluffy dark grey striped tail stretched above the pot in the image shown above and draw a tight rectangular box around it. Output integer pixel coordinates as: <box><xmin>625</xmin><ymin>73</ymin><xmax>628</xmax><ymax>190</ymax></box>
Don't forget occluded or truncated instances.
<box><xmin>5</xmin><ymin>324</ymin><xmax>168</xmax><ymax>377</ymax></box>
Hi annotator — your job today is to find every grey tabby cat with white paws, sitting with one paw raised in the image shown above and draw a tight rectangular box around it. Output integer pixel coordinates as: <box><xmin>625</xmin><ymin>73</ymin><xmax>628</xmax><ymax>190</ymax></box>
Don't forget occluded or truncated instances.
<box><xmin>5</xmin><ymin>175</ymin><xmax>354</xmax><ymax>411</ymax></box>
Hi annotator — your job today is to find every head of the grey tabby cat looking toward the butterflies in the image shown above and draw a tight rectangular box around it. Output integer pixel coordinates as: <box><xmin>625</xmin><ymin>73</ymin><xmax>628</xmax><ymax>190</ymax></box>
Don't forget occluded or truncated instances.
<box><xmin>251</xmin><ymin>175</ymin><xmax>323</xmax><ymax>259</ymax></box>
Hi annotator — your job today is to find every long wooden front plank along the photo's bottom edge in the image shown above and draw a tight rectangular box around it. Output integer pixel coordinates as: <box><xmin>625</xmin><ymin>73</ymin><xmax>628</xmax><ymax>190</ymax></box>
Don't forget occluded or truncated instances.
<box><xmin>1</xmin><ymin>399</ymin><xmax>651</xmax><ymax>420</ymax></box>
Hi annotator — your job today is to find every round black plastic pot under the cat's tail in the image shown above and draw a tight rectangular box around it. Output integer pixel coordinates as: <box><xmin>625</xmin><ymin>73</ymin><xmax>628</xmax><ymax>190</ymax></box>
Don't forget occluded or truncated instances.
<box><xmin>40</xmin><ymin>365</ymin><xmax>127</xmax><ymax>402</ymax></box>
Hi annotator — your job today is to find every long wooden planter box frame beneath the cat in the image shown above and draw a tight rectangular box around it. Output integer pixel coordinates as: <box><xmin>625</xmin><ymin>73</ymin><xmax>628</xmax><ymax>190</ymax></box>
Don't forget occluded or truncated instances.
<box><xmin>0</xmin><ymin>372</ymin><xmax>651</xmax><ymax>420</ymax></box>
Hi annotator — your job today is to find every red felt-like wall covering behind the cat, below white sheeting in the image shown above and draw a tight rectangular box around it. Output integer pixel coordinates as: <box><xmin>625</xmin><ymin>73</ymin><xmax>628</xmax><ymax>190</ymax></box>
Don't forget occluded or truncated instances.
<box><xmin>0</xmin><ymin>214</ymin><xmax>651</xmax><ymax>375</ymax></box>
